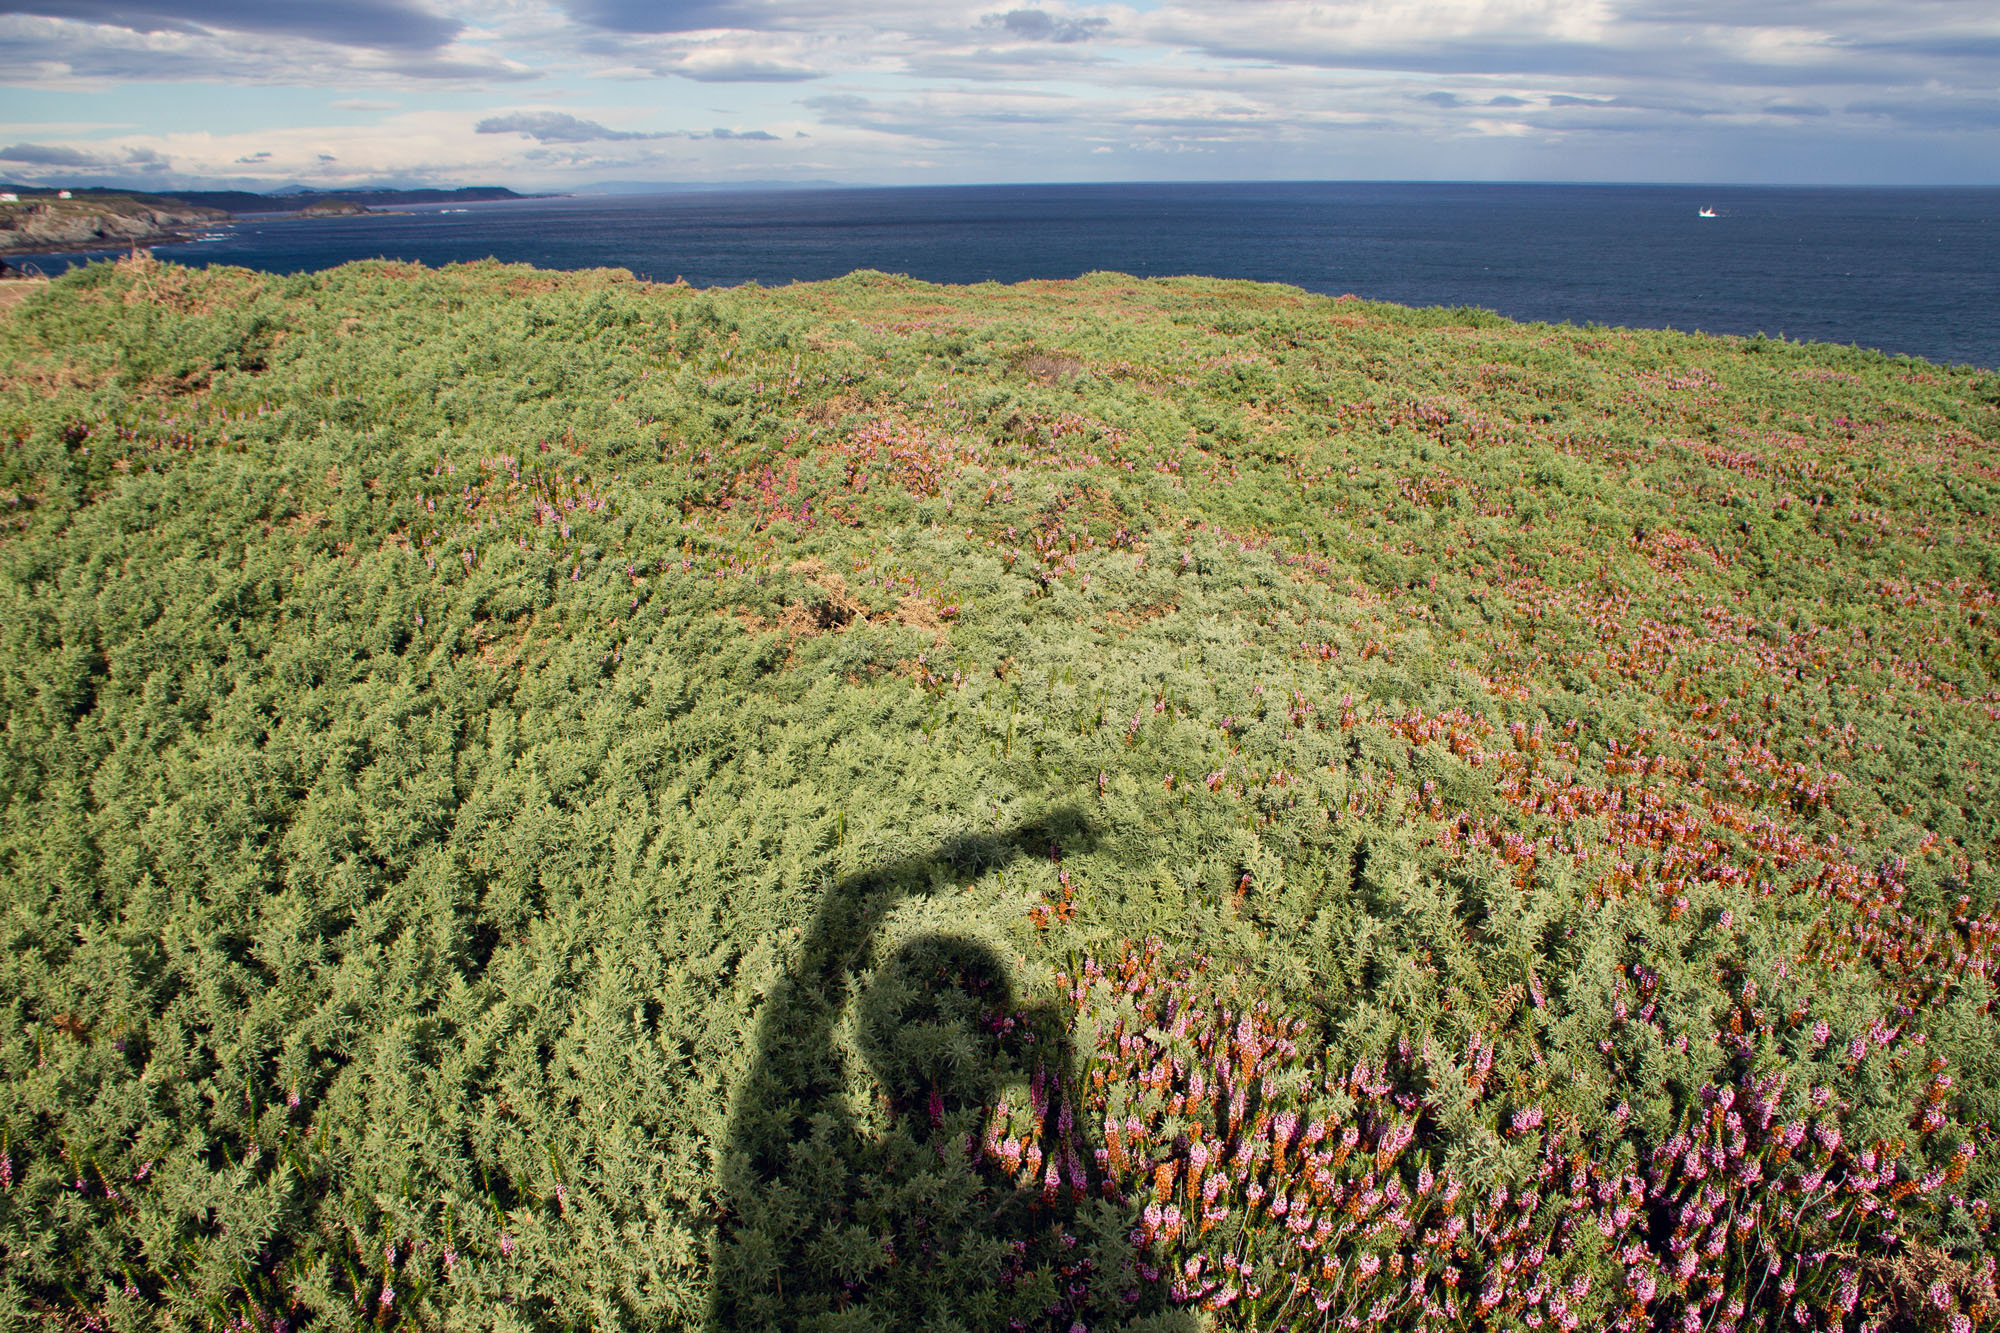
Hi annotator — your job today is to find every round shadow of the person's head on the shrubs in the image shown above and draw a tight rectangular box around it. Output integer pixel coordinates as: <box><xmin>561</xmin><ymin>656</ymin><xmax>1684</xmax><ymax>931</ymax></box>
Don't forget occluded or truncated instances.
<box><xmin>856</xmin><ymin>935</ymin><xmax>1048</xmax><ymax>1137</ymax></box>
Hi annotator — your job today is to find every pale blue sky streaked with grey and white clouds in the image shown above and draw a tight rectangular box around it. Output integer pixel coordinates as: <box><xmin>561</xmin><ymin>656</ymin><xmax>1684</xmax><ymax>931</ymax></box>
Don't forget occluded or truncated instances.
<box><xmin>0</xmin><ymin>0</ymin><xmax>2000</xmax><ymax>190</ymax></box>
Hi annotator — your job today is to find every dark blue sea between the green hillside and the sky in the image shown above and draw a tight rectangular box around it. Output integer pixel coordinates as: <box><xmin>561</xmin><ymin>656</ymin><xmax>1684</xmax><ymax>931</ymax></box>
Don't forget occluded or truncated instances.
<box><xmin>27</xmin><ymin>182</ymin><xmax>2000</xmax><ymax>366</ymax></box>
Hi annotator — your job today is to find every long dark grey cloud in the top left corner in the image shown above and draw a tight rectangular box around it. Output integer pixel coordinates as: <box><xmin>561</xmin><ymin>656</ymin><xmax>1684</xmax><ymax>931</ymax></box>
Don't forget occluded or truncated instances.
<box><xmin>0</xmin><ymin>0</ymin><xmax>464</xmax><ymax>52</ymax></box>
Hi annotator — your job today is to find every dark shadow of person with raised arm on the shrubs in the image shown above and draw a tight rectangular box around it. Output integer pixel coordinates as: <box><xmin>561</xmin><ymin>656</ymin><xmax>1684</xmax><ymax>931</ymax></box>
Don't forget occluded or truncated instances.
<box><xmin>708</xmin><ymin>815</ymin><xmax>1164</xmax><ymax>1333</ymax></box>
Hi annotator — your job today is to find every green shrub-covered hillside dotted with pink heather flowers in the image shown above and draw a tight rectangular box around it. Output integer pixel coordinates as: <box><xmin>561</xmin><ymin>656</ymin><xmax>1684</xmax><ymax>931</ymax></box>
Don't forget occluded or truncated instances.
<box><xmin>0</xmin><ymin>262</ymin><xmax>2000</xmax><ymax>1333</ymax></box>
